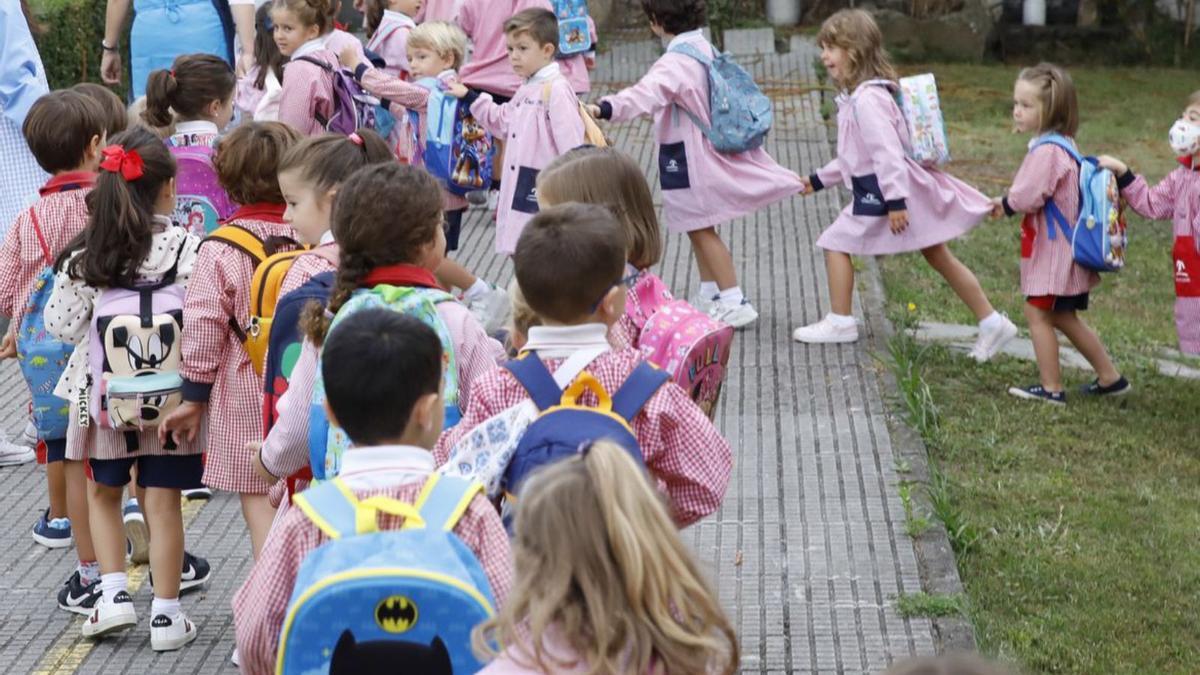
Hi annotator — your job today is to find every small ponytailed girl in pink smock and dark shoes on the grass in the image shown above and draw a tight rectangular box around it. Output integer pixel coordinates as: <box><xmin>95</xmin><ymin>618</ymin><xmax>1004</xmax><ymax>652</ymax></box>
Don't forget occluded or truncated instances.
<box><xmin>996</xmin><ymin>64</ymin><xmax>1133</xmax><ymax>406</ymax></box>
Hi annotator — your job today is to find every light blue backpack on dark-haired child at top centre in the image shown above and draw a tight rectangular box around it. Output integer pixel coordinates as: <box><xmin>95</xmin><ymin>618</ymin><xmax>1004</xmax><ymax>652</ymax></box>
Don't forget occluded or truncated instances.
<box><xmin>671</xmin><ymin>42</ymin><xmax>773</xmax><ymax>154</ymax></box>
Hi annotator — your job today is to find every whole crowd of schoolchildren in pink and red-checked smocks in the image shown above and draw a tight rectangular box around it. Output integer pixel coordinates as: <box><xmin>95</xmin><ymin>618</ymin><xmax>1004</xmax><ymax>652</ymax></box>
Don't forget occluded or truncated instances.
<box><xmin>0</xmin><ymin>0</ymin><xmax>1200</xmax><ymax>673</ymax></box>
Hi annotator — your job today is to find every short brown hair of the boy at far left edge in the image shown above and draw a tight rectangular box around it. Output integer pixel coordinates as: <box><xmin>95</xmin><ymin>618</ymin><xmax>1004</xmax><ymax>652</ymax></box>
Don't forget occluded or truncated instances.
<box><xmin>20</xmin><ymin>89</ymin><xmax>108</xmax><ymax>173</ymax></box>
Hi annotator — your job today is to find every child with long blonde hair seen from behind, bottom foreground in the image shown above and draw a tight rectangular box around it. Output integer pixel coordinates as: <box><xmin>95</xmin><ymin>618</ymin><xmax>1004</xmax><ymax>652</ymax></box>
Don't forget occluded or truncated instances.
<box><xmin>474</xmin><ymin>442</ymin><xmax>738</xmax><ymax>675</ymax></box>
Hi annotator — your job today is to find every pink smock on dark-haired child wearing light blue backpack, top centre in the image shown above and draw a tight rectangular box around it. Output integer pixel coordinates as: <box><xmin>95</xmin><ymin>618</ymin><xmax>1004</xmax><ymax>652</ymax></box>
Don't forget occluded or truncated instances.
<box><xmin>600</xmin><ymin>30</ymin><xmax>802</xmax><ymax>232</ymax></box>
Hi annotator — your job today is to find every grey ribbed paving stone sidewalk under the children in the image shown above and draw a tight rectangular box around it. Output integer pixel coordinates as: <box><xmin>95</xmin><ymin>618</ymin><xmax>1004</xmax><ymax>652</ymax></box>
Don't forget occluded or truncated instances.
<box><xmin>0</xmin><ymin>31</ymin><xmax>935</xmax><ymax>674</ymax></box>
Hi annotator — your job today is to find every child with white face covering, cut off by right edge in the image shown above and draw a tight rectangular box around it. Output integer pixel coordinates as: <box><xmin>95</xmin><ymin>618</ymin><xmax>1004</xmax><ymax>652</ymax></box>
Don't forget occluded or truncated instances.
<box><xmin>1099</xmin><ymin>91</ymin><xmax>1200</xmax><ymax>354</ymax></box>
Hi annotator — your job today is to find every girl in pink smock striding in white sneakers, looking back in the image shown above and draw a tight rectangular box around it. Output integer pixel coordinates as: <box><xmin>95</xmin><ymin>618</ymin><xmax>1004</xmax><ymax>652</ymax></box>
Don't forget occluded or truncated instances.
<box><xmin>792</xmin><ymin>10</ymin><xmax>1016</xmax><ymax>363</ymax></box>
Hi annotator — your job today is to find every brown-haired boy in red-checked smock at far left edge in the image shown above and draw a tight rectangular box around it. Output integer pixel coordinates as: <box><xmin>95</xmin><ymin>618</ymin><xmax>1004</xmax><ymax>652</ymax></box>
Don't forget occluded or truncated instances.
<box><xmin>0</xmin><ymin>91</ymin><xmax>108</xmax><ymax>613</ymax></box>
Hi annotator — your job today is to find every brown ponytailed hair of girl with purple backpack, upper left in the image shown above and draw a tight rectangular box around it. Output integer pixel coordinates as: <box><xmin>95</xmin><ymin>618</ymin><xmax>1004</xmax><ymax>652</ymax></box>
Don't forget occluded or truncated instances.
<box><xmin>142</xmin><ymin>54</ymin><xmax>238</xmax><ymax>126</ymax></box>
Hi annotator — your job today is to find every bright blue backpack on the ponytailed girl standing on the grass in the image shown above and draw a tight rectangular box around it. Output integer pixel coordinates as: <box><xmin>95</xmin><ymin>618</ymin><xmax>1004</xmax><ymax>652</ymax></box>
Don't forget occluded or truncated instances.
<box><xmin>1031</xmin><ymin>133</ymin><xmax>1128</xmax><ymax>271</ymax></box>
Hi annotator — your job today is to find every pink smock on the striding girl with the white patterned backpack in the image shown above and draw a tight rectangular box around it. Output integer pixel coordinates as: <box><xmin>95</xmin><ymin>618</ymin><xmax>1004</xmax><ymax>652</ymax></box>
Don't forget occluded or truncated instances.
<box><xmin>810</xmin><ymin>79</ymin><xmax>991</xmax><ymax>256</ymax></box>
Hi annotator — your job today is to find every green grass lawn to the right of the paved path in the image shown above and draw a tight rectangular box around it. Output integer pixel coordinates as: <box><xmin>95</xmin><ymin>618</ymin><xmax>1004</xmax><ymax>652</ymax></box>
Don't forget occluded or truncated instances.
<box><xmin>883</xmin><ymin>65</ymin><xmax>1200</xmax><ymax>673</ymax></box>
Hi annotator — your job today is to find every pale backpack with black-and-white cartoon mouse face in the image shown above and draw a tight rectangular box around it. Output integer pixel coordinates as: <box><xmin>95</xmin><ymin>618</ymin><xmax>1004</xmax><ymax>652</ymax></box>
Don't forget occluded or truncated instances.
<box><xmin>87</xmin><ymin>244</ymin><xmax>185</xmax><ymax>431</ymax></box>
